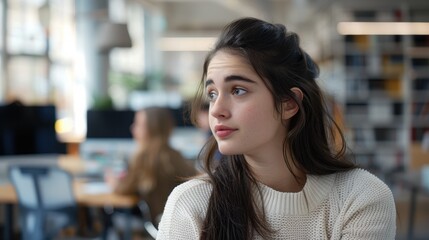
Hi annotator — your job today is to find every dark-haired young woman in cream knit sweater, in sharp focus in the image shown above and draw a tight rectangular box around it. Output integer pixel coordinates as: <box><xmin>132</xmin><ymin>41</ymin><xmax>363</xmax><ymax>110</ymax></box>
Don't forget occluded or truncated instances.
<box><xmin>158</xmin><ymin>18</ymin><xmax>396</xmax><ymax>240</ymax></box>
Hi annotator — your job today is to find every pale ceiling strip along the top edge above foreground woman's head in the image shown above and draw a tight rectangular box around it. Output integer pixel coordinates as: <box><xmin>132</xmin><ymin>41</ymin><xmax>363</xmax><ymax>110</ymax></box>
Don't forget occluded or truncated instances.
<box><xmin>139</xmin><ymin>0</ymin><xmax>429</xmax><ymax>32</ymax></box>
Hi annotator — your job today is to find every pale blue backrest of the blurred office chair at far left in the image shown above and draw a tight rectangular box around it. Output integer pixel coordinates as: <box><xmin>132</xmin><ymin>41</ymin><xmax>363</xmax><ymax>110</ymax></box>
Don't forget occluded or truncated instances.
<box><xmin>9</xmin><ymin>165</ymin><xmax>76</xmax><ymax>210</ymax></box>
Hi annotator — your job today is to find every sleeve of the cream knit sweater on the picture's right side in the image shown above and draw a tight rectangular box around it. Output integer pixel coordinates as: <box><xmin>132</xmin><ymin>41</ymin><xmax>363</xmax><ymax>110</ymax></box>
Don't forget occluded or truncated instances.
<box><xmin>340</xmin><ymin>170</ymin><xmax>396</xmax><ymax>240</ymax></box>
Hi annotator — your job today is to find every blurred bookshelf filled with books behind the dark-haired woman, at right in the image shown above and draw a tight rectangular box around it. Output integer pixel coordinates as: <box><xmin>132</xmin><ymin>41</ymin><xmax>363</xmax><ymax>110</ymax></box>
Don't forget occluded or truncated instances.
<box><xmin>336</xmin><ymin>6</ymin><xmax>422</xmax><ymax>173</ymax></box>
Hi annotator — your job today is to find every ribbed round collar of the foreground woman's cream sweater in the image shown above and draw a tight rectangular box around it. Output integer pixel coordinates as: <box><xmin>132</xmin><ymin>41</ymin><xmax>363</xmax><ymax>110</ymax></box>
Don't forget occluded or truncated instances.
<box><xmin>254</xmin><ymin>174</ymin><xmax>335</xmax><ymax>215</ymax></box>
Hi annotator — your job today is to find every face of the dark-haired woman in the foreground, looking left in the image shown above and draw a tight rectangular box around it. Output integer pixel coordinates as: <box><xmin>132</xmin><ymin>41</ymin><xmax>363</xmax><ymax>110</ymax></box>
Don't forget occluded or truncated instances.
<box><xmin>205</xmin><ymin>51</ymin><xmax>286</xmax><ymax>158</ymax></box>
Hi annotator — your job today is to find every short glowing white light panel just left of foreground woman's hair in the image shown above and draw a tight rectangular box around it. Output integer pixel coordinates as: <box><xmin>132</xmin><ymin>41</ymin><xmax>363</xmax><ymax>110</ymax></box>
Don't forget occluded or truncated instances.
<box><xmin>160</xmin><ymin>37</ymin><xmax>216</xmax><ymax>51</ymax></box>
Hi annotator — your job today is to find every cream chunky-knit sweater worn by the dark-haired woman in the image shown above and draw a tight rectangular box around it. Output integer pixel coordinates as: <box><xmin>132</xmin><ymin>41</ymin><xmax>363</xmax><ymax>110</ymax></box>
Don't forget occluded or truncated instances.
<box><xmin>157</xmin><ymin>169</ymin><xmax>396</xmax><ymax>240</ymax></box>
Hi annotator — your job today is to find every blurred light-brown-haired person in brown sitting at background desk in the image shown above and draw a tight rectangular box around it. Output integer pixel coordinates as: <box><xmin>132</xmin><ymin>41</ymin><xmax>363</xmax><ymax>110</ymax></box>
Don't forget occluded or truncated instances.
<box><xmin>107</xmin><ymin>107</ymin><xmax>196</xmax><ymax>222</ymax></box>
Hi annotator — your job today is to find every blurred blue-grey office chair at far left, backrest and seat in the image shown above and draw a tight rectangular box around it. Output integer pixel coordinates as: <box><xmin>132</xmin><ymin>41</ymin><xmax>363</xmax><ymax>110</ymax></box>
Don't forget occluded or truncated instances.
<box><xmin>8</xmin><ymin>165</ymin><xmax>77</xmax><ymax>240</ymax></box>
